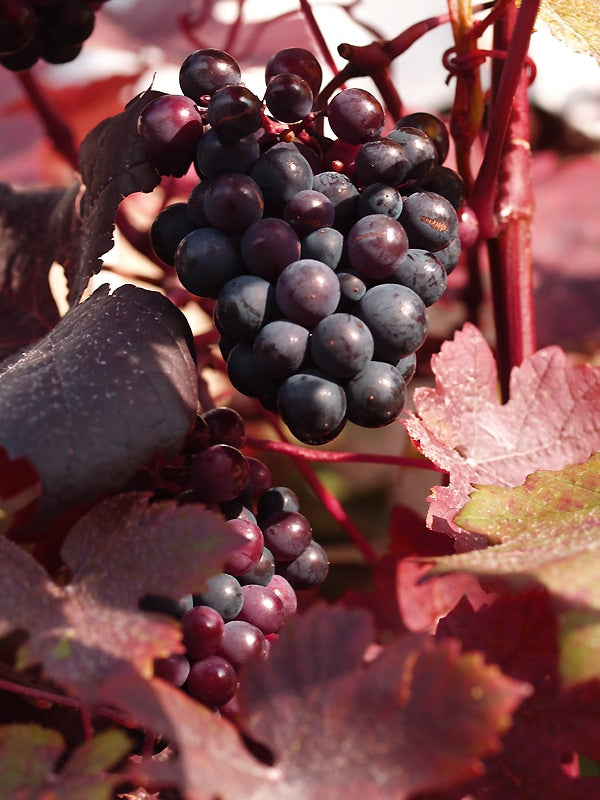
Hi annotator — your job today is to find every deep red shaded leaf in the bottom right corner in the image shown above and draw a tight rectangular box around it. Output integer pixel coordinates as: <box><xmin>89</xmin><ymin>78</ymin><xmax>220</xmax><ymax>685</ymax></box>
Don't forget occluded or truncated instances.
<box><xmin>437</xmin><ymin>588</ymin><xmax>600</xmax><ymax>800</ymax></box>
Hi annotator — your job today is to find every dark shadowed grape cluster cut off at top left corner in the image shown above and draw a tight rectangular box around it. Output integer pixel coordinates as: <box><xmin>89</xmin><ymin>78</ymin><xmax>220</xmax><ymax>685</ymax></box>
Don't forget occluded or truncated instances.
<box><xmin>0</xmin><ymin>0</ymin><xmax>107</xmax><ymax>72</ymax></box>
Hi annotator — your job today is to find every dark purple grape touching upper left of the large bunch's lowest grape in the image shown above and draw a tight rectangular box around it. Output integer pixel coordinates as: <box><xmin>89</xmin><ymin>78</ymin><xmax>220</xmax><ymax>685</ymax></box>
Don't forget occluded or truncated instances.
<box><xmin>252</xmin><ymin>319</ymin><xmax>309</xmax><ymax>378</ymax></box>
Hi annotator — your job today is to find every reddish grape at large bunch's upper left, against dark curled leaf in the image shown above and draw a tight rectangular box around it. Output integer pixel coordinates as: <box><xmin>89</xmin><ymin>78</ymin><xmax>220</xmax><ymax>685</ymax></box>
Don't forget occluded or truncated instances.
<box><xmin>137</xmin><ymin>94</ymin><xmax>204</xmax><ymax>164</ymax></box>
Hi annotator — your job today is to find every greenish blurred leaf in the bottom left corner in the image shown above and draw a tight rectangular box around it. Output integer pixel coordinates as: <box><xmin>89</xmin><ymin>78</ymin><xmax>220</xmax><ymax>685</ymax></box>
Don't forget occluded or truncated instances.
<box><xmin>0</xmin><ymin>724</ymin><xmax>131</xmax><ymax>800</ymax></box>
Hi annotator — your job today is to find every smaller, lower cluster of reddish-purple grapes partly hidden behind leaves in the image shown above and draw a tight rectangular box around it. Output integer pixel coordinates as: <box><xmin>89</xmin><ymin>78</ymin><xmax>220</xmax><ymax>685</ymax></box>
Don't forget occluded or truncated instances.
<box><xmin>140</xmin><ymin>407</ymin><xmax>329</xmax><ymax>708</ymax></box>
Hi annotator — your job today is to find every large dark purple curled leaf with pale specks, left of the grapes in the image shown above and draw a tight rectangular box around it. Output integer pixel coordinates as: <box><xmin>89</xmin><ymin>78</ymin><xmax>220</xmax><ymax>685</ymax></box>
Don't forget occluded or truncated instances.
<box><xmin>0</xmin><ymin>285</ymin><xmax>197</xmax><ymax>522</ymax></box>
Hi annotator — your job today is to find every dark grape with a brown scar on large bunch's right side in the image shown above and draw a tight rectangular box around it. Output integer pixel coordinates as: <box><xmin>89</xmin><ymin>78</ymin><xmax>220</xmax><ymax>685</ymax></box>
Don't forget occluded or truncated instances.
<box><xmin>400</xmin><ymin>192</ymin><xmax>458</xmax><ymax>252</ymax></box>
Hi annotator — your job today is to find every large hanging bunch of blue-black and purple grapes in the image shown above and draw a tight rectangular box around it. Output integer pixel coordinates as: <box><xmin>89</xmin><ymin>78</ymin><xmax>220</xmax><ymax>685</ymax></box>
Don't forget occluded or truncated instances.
<box><xmin>138</xmin><ymin>48</ymin><xmax>464</xmax><ymax>445</ymax></box>
